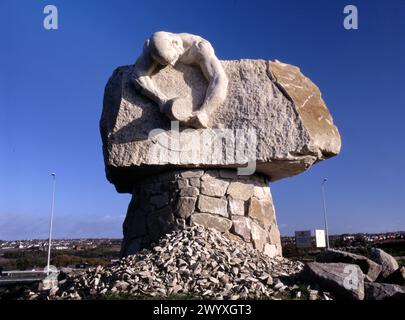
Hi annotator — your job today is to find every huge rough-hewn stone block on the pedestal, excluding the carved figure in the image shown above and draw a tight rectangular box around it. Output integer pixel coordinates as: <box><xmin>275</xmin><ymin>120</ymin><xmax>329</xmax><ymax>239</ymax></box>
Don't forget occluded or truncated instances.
<box><xmin>100</xmin><ymin>60</ymin><xmax>340</xmax><ymax>192</ymax></box>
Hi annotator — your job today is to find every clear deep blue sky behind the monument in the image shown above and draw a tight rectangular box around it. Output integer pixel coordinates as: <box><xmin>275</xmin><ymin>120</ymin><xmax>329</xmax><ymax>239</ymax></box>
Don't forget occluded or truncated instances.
<box><xmin>0</xmin><ymin>0</ymin><xmax>405</xmax><ymax>239</ymax></box>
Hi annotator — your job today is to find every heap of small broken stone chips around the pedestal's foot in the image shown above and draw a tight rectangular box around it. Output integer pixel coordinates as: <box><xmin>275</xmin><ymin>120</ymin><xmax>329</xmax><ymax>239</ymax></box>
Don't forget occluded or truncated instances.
<box><xmin>26</xmin><ymin>226</ymin><xmax>331</xmax><ymax>300</ymax></box>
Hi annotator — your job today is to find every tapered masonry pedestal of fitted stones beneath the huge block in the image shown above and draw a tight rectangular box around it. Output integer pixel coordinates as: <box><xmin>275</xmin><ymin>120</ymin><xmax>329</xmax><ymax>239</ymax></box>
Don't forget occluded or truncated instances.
<box><xmin>121</xmin><ymin>169</ymin><xmax>282</xmax><ymax>257</ymax></box>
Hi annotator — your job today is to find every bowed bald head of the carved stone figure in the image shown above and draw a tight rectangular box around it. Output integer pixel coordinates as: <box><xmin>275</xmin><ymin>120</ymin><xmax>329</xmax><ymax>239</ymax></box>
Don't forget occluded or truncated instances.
<box><xmin>150</xmin><ymin>31</ymin><xmax>184</xmax><ymax>65</ymax></box>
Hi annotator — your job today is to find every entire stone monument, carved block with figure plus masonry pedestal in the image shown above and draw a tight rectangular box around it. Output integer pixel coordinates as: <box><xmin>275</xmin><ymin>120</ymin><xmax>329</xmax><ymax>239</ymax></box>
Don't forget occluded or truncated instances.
<box><xmin>100</xmin><ymin>32</ymin><xmax>341</xmax><ymax>257</ymax></box>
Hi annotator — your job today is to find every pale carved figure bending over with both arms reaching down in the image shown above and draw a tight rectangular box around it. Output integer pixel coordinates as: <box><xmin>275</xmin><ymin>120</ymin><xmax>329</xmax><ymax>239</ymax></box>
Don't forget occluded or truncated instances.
<box><xmin>133</xmin><ymin>31</ymin><xmax>228</xmax><ymax>128</ymax></box>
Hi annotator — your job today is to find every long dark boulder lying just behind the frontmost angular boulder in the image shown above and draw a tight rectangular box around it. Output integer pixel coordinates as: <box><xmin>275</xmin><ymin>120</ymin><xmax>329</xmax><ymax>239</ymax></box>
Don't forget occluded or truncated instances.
<box><xmin>316</xmin><ymin>249</ymin><xmax>382</xmax><ymax>281</ymax></box>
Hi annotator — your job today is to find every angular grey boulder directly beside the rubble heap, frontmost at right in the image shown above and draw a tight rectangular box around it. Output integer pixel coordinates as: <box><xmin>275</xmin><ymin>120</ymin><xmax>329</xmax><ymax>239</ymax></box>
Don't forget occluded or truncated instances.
<box><xmin>303</xmin><ymin>262</ymin><xmax>364</xmax><ymax>300</ymax></box>
